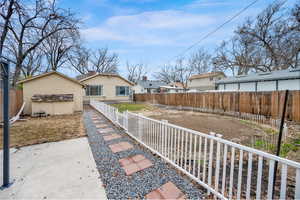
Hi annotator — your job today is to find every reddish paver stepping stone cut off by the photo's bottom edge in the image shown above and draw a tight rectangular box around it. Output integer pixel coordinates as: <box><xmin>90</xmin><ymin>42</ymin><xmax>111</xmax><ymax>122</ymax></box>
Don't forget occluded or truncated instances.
<box><xmin>146</xmin><ymin>181</ymin><xmax>186</xmax><ymax>199</ymax></box>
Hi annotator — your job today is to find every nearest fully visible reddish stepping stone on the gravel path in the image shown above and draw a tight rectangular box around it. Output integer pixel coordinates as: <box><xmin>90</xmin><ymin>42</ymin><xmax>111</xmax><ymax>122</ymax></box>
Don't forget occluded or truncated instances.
<box><xmin>119</xmin><ymin>155</ymin><xmax>153</xmax><ymax>176</ymax></box>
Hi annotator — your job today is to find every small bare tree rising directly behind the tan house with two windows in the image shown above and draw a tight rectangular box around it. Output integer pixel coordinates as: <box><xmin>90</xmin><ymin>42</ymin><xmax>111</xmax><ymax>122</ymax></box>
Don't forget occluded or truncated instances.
<box><xmin>90</xmin><ymin>48</ymin><xmax>119</xmax><ymax>74</ymax></box>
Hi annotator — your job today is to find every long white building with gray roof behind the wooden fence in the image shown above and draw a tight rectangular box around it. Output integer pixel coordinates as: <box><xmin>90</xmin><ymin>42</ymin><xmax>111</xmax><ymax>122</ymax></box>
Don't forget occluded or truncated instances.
<box><xmin>216</xmin><ymin>68</ymin><xmax>300</xmax><ymax>91</ymax></box>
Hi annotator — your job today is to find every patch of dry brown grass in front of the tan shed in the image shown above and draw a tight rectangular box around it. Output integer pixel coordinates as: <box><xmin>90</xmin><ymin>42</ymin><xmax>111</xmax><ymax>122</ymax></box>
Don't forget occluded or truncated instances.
<box><xmin>0</xmin><ymin>113</ymin><xmax>85</xmax><ymax>149</ymax></box>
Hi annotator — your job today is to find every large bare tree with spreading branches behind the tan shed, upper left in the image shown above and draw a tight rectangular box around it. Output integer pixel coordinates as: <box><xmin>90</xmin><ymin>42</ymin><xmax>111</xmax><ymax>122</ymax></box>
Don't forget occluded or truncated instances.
<box><xmin>7</xmin><ymin>0</ymin><xmax>78</xmax><ymax>85</ymax></box>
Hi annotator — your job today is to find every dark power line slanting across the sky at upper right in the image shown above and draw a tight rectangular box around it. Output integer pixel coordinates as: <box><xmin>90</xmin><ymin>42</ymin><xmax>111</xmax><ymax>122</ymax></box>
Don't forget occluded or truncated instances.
<box><xmin>174</xmin><ymin>0</ymin><xmax>259</xmax><ymax>58</ymax></box>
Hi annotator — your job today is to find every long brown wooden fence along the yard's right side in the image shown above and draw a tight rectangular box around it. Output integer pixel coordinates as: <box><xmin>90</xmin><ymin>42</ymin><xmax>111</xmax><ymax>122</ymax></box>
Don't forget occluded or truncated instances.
<box><xmin>134</xmin><ymin>90</ymin><xmax>300</xmax><ymax>122</ymax></box>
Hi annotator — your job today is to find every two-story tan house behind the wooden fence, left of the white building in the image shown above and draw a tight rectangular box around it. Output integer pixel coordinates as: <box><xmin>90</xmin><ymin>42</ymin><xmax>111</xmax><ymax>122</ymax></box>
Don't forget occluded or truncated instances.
<box><xmin>187</xmin><ymin>72</ymin><xmax>226</xmax><ymax>91</ymax></box>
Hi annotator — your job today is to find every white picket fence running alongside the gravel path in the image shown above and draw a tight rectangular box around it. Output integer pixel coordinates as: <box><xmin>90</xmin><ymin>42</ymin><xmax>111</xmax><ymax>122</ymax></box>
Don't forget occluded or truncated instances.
<box><xmin>90</xmin><ymin>101</ymin><xmax>300</xmax><ymax>199</ymax></box>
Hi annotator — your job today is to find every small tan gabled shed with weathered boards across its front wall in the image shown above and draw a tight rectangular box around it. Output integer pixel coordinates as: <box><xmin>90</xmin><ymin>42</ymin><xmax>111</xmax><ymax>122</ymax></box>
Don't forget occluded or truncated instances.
<box><xmin>18</xmin><ymin>72</ymin><xmax>84</xmax><ymax>115</ymax></box>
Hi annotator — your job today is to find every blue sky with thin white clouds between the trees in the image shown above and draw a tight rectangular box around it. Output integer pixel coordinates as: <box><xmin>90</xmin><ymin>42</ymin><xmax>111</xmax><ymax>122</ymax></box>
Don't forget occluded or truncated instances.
<box><xmin>58</xmin><ymin>0</ymin><xmax>297</xmax><ymax>76</ymax></box>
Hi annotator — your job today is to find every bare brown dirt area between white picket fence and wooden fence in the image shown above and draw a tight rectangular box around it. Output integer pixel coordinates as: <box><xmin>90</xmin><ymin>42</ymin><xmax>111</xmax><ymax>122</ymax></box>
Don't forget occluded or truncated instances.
<box><xmin>139</xmin><ymin>107</ymin><xmax>270</xmax><ymax>143</ymax></box>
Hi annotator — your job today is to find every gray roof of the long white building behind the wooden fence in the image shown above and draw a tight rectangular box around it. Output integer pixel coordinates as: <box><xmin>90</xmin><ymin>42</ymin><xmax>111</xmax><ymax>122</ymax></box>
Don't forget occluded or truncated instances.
<box><xmin>216</xmin><ymin>68</ymin><xmax>300</xmax><ymax>84</ymax></box>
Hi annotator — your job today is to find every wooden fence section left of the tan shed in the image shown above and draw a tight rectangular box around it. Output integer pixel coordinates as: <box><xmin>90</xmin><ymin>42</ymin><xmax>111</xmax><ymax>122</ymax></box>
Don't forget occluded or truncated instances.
<box><xmin>0</xmin><ymin>89</ymin><xmax>23</xmax><ymax>121</ymax></box>
